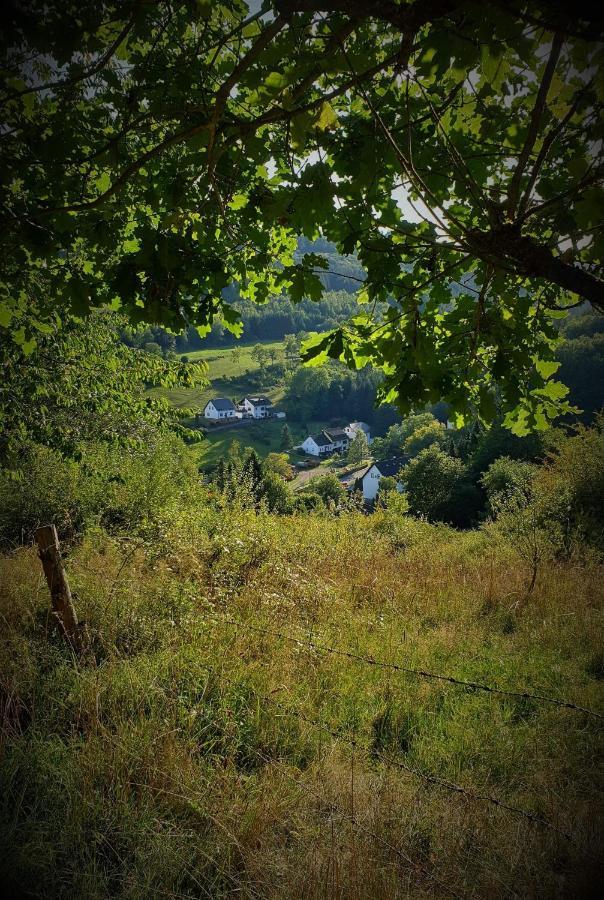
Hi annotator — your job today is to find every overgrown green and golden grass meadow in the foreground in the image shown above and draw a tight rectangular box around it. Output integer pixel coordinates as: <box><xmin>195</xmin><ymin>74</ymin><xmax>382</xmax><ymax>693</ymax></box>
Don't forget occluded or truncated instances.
<box><xmin>0</xmin><ymin>504</ymin><xmax>604</xmax><ymax>900</ymax></box>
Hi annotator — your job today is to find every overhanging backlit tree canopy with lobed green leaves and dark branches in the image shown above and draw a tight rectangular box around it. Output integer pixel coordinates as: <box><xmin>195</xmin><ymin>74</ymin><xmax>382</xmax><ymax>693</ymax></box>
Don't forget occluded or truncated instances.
<box><xmin>0</xmin><ymin>0</ymin><xmax>604</xmax><ymax>433</ymax></box>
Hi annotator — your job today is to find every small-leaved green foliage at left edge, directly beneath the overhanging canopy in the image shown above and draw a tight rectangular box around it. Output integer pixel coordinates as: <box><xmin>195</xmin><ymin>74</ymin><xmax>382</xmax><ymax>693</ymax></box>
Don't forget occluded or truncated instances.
<box><xmin>0</xmin><ymin>313</ymin><xmax>206</xmax><ymax>468</ymax></box>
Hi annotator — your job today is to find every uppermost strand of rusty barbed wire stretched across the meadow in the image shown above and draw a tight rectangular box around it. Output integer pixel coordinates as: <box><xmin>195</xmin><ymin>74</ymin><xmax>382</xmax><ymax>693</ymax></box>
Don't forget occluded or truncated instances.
<box><xmin>215</xmin><ymin>616</ymin><xmax>604</xmax><ymax>719</ymax></box>
